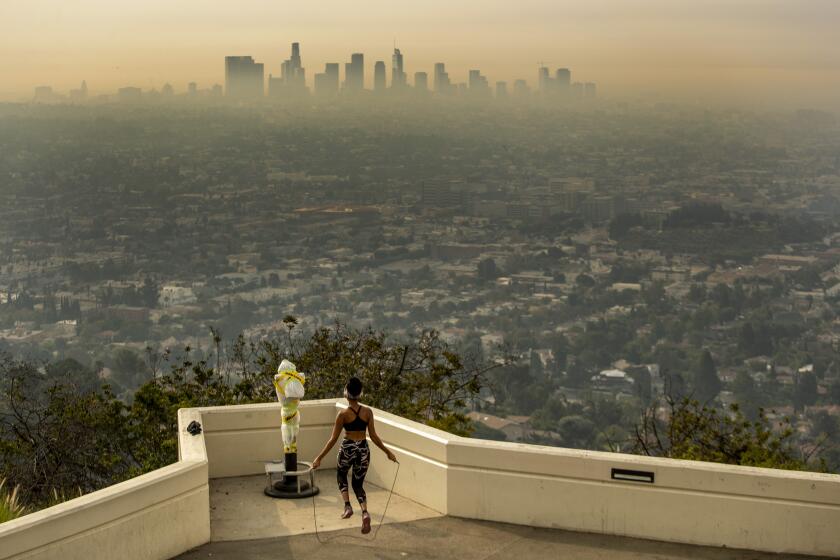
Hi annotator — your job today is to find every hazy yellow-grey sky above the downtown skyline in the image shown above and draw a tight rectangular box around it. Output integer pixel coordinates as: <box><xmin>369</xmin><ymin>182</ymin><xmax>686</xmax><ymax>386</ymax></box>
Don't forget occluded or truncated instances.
<box><xmin>0</xmin><ymin>0</ymin><xmax>840</xmax><ymax>108</ymax></box>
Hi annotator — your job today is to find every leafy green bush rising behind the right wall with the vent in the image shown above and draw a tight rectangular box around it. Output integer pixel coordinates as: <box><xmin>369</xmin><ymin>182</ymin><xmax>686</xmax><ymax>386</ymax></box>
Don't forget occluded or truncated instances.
<box><xmin>633</xmin><ymin>398</ymin><xmax>808</xmax><ymax>470</ymax></box>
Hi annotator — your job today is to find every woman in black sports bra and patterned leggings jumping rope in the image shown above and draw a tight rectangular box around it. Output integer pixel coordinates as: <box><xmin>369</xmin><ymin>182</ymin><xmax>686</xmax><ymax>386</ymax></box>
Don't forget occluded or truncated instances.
<box><xmin>312</xmin><ymin>377</ymin><xmax>397</xmax><ymax>535</ymax></box>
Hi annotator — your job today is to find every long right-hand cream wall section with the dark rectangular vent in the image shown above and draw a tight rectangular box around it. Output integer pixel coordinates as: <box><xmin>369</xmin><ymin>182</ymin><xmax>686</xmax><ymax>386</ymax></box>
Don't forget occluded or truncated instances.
<box><xmin>447</xmin><ymin>438</ymin><xmax>840</xmax><ymax>556</ymax></box>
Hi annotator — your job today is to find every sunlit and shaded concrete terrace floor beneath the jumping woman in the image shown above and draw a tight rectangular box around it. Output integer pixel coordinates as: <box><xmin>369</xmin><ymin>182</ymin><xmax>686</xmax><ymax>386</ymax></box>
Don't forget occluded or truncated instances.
<box><xmin>178</xmin><ymin>471</ymin><xmax>813</xmax><ymax>560</ymax></box>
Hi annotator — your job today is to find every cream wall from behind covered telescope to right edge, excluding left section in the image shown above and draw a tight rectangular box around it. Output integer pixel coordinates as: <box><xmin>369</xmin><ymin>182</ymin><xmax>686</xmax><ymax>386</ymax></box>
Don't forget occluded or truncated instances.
<box><xmin>192</xmin><ymin>400</ymin><xmax>840</xmax><ymax>556</ymax></box>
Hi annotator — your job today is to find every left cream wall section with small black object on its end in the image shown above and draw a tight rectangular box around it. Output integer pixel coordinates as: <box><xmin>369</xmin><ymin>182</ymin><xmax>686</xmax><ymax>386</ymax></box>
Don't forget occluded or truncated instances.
<box><xmin>0</xmin><ymin>411</ymin><xmax>210</xmax><ymax>560</ymax></box>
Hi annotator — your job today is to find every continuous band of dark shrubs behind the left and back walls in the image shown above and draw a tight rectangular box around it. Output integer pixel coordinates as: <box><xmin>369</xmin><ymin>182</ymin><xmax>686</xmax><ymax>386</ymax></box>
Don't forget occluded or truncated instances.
<box><xmin>0</xmin><ymin>317</ymin><xmax>504</xmax><ymax>516</ymax></box>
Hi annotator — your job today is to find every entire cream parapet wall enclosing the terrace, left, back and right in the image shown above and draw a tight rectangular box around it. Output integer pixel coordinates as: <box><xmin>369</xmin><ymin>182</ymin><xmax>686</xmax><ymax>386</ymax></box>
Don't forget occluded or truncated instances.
<box><xmin>0</xmin><ymin>400</ymin><xmax>840</xmax><ymax>560</ymax></box>
